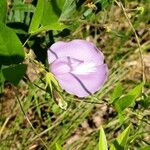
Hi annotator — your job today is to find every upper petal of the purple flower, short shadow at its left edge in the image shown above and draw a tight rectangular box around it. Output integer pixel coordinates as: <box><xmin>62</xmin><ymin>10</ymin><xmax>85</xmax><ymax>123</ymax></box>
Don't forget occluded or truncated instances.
<box><xmin>48</xmin><ymin>40</ymin><xmax>104</xmax><ymax>65</ymax></box>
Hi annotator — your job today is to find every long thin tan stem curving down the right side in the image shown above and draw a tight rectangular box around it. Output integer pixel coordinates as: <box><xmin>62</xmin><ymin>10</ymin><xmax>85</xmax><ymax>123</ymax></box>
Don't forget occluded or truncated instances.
<box><xmin>115</xmin><ymin>0</ymin><xmax>146</xmax><ymax>93</ymax></box>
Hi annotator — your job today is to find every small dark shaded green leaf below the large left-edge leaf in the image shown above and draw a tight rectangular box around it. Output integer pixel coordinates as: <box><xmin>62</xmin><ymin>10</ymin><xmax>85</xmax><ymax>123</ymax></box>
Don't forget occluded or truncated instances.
<box><xmin>2</xmin><ymin>64</ymin><xmax>27</xmax><ymax>85</ymax></box>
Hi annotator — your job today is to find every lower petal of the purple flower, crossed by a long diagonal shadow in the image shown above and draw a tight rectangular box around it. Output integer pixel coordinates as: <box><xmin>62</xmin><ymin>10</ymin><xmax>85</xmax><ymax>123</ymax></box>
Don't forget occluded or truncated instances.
<box><xmin>52</xmin><ymin>64</ymin><xmax>108</xmax><ymax>97</ymax></box>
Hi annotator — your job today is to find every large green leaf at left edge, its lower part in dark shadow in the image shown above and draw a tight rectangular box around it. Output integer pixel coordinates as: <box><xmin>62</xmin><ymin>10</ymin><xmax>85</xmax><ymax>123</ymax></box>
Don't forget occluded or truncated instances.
<box><xmin>0</xmin><ymin>23</ymin><xmax>25</xmax><ymax>65</ymax></box>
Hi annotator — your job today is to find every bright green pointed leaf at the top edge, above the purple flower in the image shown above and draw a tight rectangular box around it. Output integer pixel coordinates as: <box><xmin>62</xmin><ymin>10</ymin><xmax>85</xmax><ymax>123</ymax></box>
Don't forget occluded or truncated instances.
<box><xmin>29</xmin><ymin>0</ymin><xmax>64</xmax><ymax>34</ymax></box>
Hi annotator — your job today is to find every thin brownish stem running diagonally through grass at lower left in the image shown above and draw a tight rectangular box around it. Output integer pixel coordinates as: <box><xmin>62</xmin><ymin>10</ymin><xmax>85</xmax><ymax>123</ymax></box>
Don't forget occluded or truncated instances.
<box><xmin>13</xmin><ymin>87</ymin><xmax>48</xmax><ymax>150</ymax></box>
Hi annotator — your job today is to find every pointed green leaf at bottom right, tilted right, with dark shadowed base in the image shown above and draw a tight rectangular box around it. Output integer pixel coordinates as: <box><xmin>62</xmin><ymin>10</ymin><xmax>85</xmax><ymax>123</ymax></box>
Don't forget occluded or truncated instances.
<box><xmin>110</xmin><ymin>125</ymin><xmax>131</xmax><ymax>150</ymax></box>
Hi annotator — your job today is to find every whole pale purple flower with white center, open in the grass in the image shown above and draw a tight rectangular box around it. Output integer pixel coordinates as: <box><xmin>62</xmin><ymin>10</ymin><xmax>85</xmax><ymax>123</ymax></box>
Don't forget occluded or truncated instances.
<box><xmin>48</xmin><ymin>39</ymin><xmax>108</xmax><ymax>97</ymax></box>
